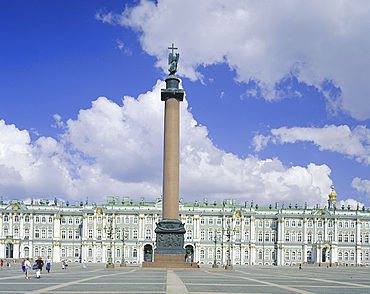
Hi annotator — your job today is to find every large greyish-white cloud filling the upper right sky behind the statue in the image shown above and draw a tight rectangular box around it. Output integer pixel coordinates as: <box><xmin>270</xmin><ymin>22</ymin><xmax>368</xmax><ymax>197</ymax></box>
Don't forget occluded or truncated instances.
<box><xmin>96</xmin><ymin>0</ymin><xmax>370</xmax><ymax>120</ymax></box>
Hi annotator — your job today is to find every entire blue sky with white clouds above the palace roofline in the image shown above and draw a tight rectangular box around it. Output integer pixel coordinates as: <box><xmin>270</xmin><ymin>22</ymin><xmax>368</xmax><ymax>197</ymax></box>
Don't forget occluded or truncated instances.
<box><xmin>0</xmin><ymin>0</ymin><xmax>370</xmax><ymax>206</ymax></box>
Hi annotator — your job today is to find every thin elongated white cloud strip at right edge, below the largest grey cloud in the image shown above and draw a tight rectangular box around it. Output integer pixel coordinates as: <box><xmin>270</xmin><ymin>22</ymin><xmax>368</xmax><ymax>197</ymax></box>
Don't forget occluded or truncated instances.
<box><xmin>253</xmin><ymin>125</ymin><xmax>370</xmax><ymax>165</ymax></box>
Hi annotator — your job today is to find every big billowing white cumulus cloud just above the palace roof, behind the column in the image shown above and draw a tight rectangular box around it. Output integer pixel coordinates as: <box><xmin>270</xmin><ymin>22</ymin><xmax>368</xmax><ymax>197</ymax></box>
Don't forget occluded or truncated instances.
<box><xmin>0</xmin><ymin>81</ymin><xmax>331</xmax><ymax>205</ymax></box>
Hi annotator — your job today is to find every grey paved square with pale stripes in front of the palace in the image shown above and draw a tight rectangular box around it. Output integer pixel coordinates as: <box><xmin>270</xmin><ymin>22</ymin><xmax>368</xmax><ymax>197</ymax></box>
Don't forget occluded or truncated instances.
<box><xmin>0</xmin><ymin>264</ymin><xmax>370</xmax><ymax>294</ymax></box>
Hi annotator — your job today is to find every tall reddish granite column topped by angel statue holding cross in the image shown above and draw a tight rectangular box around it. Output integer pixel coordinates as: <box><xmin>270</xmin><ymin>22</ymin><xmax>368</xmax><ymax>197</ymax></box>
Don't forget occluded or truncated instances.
<box><xmin>148</xmin><ymin>44</ymin><xmax>185</xmax><ymax>266</ymax></box>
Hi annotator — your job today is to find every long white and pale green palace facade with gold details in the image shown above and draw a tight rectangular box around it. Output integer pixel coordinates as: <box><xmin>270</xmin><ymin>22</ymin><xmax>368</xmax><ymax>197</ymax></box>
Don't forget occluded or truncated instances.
<box><xmin>0</xmin><ymin>187</ymin><xmax>370</xmax><ymax>266</ymax></box>
